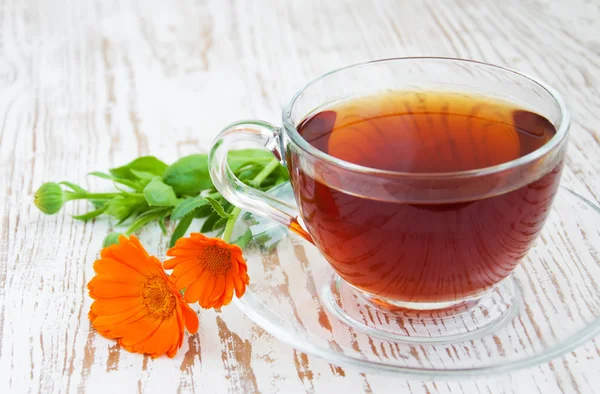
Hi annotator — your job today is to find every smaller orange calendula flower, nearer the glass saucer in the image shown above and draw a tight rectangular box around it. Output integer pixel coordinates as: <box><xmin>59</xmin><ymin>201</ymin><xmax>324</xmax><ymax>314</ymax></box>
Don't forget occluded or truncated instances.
<box><xmin>164</xmin><ymin>233</ymin><xmax>250</xmax><ymax>308</ymax></box>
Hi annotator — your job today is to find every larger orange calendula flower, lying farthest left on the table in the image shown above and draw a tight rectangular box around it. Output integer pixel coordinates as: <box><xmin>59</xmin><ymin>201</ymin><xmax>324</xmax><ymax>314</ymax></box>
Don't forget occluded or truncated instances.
<box><xmin>88</xmin><ymin>235</ymin><xmax>198</xmax><ymax>357</ymax></box>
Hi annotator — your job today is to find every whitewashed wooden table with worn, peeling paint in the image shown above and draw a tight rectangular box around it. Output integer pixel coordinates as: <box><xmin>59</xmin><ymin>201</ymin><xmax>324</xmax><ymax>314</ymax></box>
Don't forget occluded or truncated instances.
<box><xmin>0</xmin><ymin>0</ymin><xmax>600</xmax><ymax>393</ymax></box>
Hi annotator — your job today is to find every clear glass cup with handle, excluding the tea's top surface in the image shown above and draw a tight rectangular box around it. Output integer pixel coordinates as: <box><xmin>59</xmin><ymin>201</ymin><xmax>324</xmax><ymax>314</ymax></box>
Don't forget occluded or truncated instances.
<box><xmin>209</xmin><ymin>58</ymin><xmax>570</xmax><ymax>338</ymax></box>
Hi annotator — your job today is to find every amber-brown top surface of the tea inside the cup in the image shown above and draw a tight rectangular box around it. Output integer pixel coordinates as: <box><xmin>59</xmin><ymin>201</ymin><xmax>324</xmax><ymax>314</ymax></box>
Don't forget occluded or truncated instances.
<box><xmin>299</xmin><ymin>92</ymin><xmax>556</xmax><ymax>172</ymax></box>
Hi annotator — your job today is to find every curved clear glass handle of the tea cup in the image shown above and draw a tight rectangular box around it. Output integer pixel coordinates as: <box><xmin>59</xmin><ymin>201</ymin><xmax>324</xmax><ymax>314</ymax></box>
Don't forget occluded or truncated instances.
<box><xmin>208</xmin><ymin>120</ymin><xmax>313</xmax><ymax>243</ymax></box>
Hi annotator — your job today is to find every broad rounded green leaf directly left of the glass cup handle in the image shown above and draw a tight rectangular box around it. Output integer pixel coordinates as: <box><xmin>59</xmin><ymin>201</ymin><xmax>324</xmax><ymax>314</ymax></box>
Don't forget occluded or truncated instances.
<box><xmin>163</xmin><ymin>154</ymin><xmax>213</xmax><ymax>196</ymax></box>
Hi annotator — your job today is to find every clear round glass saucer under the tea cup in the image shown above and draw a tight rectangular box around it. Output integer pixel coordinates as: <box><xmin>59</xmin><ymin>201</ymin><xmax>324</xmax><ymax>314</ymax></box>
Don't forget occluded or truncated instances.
<box><xmin>234</xmin><ymin>184</ymin><xmax>600</xmax><ymax>378</ymax></box>
